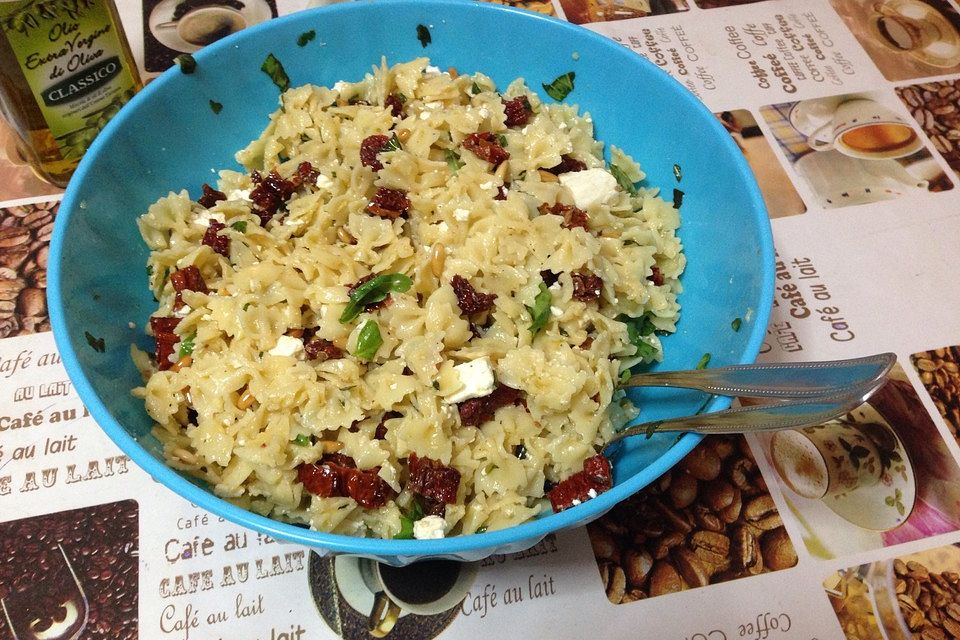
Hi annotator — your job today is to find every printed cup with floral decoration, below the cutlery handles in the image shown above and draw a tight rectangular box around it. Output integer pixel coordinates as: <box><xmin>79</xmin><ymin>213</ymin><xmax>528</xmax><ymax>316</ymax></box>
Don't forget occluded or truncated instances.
<box><xmin>770</xmin><ymin>422</ymin><xmax>883</xmax><ymax>500</ymax></box>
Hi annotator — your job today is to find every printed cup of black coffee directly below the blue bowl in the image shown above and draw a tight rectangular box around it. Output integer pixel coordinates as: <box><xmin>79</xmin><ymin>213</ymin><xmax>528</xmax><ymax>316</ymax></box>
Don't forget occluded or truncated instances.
<box><xmin>360</xmin><ymin>558</ymin><xmax>477</xmax><ymax>638</ymax></box>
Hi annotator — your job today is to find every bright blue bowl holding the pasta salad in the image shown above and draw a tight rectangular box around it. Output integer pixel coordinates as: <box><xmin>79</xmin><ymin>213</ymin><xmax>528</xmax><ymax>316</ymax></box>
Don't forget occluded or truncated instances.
<box><xmin>48</xmin><ymin>0</ymin><xmax>773</xmax><ymax>564</ymax></box>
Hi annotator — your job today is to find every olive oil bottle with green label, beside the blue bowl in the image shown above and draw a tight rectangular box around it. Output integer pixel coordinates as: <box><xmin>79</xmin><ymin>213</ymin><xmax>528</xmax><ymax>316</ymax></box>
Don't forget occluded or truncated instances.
<box><xmin>0</xmin><ymin>0</ymin><xmax>142</xmax><ymax>187</ymax></box>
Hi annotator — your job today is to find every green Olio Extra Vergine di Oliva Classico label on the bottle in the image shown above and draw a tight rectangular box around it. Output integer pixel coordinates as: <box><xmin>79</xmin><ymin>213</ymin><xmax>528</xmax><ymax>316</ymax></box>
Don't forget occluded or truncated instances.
<box><xmin>0</xmin><ymin>0</ymin><xmax>136</xmax><ymax>159</ymax></box>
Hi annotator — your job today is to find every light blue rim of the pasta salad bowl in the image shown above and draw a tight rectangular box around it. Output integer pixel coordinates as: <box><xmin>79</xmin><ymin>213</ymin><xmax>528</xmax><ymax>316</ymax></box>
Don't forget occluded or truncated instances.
<box><xmin>48</xmin><ymin>0</ymin><xmax>774</xmax><ymax>560</ymax></box>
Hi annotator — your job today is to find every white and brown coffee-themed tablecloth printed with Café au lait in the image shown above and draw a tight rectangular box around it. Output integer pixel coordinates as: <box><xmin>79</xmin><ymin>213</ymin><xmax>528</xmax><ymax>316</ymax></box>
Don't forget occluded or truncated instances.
<box><xmin>0</xmin><ymin>0</ymin><xmax>960</xmax><ymax>640</ymax></box>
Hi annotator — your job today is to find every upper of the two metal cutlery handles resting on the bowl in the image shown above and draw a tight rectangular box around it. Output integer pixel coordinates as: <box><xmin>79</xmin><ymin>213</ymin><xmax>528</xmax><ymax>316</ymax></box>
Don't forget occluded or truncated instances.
<box><xmin>621</xmin><ymin>353</ymin><xmax>897</xmax><ymax>398</ymax></box>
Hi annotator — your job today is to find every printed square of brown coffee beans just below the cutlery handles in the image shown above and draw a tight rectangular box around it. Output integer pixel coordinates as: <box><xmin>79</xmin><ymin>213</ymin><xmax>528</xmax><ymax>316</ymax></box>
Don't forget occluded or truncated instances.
<box><xmin>587</xmin><ymin>436</ymin><xmax>797</xmax><ymax>604</ymax></box>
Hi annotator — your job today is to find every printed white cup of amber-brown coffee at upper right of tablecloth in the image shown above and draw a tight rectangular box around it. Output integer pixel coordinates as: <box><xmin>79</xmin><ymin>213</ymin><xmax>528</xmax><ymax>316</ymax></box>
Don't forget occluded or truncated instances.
<box><xmin>809</xmin><ymin>98</ymin><xmax>923</xmax><ymax>160</ymax></box>
